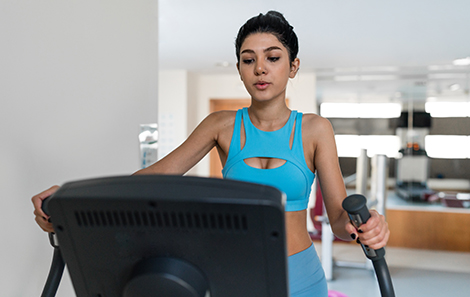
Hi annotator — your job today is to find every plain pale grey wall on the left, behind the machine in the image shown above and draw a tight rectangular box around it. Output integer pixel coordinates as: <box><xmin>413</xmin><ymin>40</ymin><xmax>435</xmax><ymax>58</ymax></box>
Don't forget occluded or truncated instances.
<box><xmin>0</xmin><ymin>0</ymin><xmax>158</xmax><ymax>297</ymax></box>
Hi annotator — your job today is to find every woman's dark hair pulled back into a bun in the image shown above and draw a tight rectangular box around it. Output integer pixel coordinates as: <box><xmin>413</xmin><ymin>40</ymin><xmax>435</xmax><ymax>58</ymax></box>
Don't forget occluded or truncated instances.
<box><xmin>235</xmin><ymin>10</ymin><xmax>299</xmax><ymax>62</ymax></box>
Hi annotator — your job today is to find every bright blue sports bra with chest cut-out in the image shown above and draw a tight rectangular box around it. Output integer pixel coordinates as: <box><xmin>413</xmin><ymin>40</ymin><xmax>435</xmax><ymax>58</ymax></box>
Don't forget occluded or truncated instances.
<box><xmin>222</xmin><ymin>108</ymin><xmax>315</xmax><ymax>211</ymax></box>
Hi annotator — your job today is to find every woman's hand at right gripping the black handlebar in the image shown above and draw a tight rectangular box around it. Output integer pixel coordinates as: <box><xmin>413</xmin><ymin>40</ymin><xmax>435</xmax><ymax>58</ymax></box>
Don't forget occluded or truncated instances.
<box><xmin>346</xmin><ymin>210</ymin><xmax>390</xmax><ymax>250</ymax></box>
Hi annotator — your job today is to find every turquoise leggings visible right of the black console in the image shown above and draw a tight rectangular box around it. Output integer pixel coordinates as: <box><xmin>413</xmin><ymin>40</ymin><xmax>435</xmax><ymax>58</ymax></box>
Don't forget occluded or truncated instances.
<box><xmin>288</xmin><ymin>244</ymin><xmax>328</xmax><ymax>297</ymax></box>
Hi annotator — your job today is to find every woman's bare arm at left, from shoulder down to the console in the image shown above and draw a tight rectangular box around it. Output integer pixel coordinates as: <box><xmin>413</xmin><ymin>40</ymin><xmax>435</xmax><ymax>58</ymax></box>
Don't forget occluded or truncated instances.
<box><xmin>137</xmin><ymin>112</ymin><xmax>232</xmax><ymax>174</ymax></box>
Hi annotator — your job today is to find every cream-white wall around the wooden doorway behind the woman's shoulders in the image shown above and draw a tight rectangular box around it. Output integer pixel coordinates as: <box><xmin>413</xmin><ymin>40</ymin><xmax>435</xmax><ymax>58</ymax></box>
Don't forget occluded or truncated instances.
<box><xmin>188</xmin><ymin>71</ymin><xmax>317</xmax><ymax>176</ymax></box>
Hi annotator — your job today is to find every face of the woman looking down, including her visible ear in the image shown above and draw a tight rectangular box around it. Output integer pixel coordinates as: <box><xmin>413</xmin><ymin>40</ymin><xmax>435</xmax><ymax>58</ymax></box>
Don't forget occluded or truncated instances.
<box><xmin>237</xmin><ymin>33</ymin><xmax>300</xmax><ymax>101</ymax></box>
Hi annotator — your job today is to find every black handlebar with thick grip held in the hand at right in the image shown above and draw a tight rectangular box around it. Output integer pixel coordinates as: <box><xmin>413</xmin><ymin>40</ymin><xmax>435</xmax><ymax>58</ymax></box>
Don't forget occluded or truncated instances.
<box><xmin>343</xmin><ymin>194</ymin><xmax>395</xmax><ymax>297</ymax></box>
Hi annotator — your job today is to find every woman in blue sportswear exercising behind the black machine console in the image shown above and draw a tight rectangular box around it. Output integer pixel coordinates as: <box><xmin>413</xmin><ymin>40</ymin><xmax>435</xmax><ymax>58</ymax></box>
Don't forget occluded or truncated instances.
<box><xmin>32</xmin><ymin>11</ymin><xmax>389</xmax><ymax>297</ymax></box>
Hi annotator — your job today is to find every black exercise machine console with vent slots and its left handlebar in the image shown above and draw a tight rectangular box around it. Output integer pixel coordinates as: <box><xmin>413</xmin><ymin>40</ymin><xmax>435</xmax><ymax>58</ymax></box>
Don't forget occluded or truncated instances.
<box><xmin>42</xmin><ymin>175</ymin><xmax>288</xmax><ymax>297</ymax></box>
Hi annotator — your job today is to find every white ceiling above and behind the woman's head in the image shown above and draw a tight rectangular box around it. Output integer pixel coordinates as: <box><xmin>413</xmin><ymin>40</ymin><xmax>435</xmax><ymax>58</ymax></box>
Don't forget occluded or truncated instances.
<box><xmin>159</xmin><ymin>0</ymin><xmax>470</xmax><ymax>102</ymax></box>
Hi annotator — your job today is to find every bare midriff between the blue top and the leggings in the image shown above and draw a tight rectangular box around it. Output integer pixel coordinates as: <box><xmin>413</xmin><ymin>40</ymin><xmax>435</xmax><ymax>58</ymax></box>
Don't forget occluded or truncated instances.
<box><xmin>285</xmin><ymin>210</ymin><xmax>312</xmax><ymax>256</ymax></box>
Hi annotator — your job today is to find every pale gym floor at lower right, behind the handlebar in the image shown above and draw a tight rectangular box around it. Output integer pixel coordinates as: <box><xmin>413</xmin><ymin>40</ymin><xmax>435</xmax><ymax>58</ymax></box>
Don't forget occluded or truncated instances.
<box><xmin>315</xmin><ymin>243</ymin><xmax>470</xmax><ymax>297</ymax></box>
